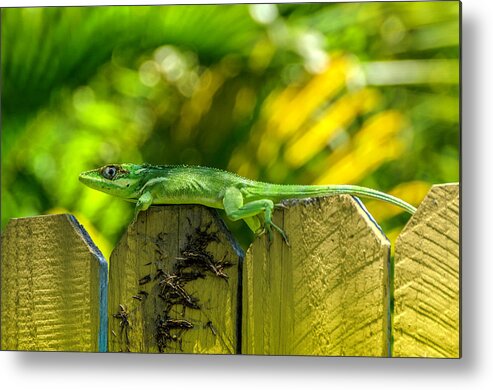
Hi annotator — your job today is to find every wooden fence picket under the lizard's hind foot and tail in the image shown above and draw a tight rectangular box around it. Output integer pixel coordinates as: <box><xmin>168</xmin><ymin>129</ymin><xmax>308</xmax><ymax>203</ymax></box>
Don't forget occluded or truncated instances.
<box><xmin>242</xmin><ymin>195</ymin><xmax>390</xmax><ymax>356</ymax></box>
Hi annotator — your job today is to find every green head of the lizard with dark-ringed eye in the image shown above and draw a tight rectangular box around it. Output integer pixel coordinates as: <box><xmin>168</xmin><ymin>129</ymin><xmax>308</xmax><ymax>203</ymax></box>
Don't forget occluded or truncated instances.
<box><xmin>79</xmin><ymin>164</ymin><xmax>145</xmax><ymax>199</ymax></box>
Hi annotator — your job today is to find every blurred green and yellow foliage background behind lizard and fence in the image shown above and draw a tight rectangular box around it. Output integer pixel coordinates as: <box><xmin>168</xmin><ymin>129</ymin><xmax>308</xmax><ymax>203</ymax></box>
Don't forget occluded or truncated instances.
<box><xmin>1</xmin><ymin>1</ymin><xmax>460</xmax><ymax>254</ymax></box>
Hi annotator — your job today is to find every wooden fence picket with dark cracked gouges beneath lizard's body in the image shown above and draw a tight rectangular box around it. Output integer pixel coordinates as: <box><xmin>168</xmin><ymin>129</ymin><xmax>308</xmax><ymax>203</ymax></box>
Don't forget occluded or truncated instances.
<box><xmin>109</xmin><ymin>206</ymin><xmax>243</xmax><ymax>354</ymax></box>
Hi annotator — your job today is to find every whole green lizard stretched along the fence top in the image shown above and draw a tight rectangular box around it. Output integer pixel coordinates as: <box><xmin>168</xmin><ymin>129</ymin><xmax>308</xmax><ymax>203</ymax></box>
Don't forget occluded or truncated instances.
<box><xmin>79</xmin><ymin>164</ymin><xmax>416</xmax><ymax>243</ymax></box>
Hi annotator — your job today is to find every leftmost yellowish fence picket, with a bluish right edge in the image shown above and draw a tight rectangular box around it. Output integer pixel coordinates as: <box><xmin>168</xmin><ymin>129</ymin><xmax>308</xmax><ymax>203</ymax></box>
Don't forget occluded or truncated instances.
<box><xmin>1</xmin><ymin>214</ymin><xmax>108</xmax><ymax>352</ymax></box>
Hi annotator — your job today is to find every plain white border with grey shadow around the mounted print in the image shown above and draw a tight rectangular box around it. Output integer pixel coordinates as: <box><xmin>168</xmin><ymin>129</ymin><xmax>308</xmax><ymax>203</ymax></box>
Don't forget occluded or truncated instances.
<box><xmin>0</xmin><ymin>0</ymin><xmax>493</xmax><ymax>390</ymax></box>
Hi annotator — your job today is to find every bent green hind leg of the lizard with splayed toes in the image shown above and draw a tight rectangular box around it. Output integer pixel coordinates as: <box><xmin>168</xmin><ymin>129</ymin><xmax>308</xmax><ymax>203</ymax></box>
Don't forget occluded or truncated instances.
<box><xmin>223</xmin><ymin>187</ymin><xmax>289</xmax><ymax>245</ymax></box>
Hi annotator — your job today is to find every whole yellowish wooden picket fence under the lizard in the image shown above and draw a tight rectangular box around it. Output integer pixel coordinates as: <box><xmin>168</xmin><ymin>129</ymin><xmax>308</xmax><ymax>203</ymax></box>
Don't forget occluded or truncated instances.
<box><xmin>0</xmin><ymin>184</ymin><xmax>460</xmax><ymax>358</ymax></box>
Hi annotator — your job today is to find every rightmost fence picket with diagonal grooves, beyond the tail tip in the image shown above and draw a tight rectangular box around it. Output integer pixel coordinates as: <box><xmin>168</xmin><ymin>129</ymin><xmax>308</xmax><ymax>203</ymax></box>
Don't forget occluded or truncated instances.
<box><xmin>393</xmin><ymin>184</ymin><xmax>460</xmax><ymax>358</ymax></box>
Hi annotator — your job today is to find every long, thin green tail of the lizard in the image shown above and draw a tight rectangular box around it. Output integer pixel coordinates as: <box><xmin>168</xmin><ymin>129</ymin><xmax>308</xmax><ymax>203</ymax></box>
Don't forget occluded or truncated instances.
<box><xmin>248</xmin><ymin>183</ymin><xmax>416</xmax><ymax>214</ymax></box>
